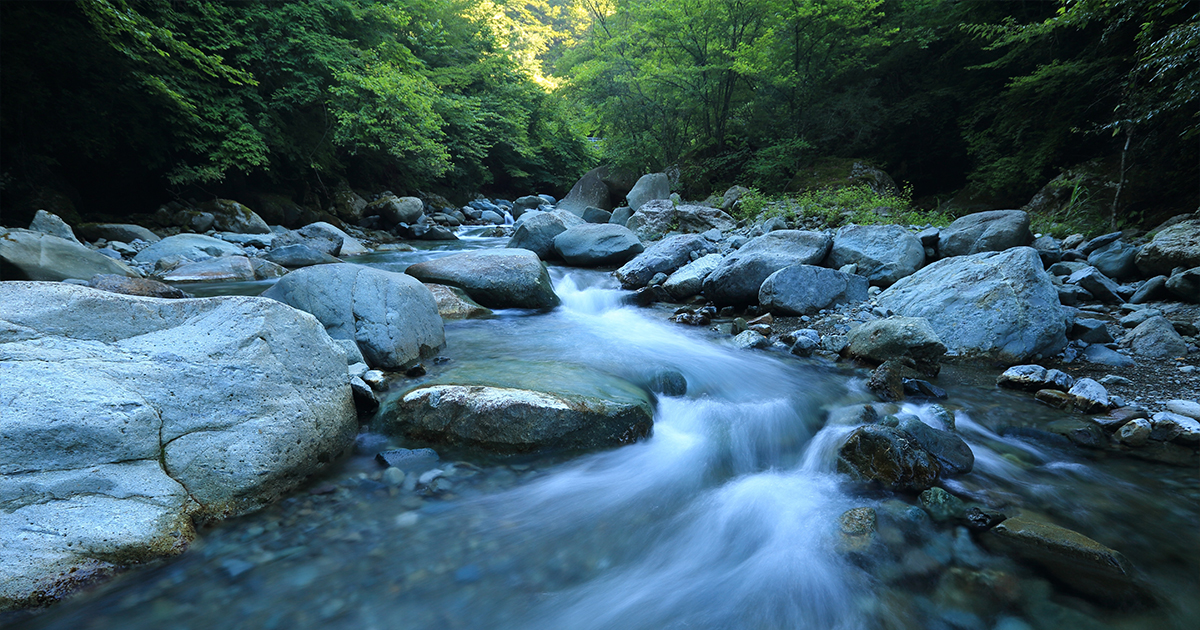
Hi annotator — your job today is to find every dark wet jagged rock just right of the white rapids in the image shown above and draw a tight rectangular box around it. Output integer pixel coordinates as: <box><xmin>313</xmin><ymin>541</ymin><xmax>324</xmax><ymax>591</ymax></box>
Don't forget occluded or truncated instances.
<box><xmin>838</xmin><ymin>425</ymin><xmax>941</xmax><ymax>492</ymax></box>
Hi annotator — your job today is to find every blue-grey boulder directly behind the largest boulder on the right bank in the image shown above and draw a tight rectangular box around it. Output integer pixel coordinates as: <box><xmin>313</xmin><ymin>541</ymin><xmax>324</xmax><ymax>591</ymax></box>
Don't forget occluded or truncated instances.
<box><xmin>826</xmin><ymin>226</ymin><xmax>925</xmax><ymax>287</ymax></box>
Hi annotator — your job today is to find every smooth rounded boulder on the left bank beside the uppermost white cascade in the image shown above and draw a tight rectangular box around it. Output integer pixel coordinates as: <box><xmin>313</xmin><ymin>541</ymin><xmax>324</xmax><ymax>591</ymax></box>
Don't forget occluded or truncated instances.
<box><xmin>406</xmin><ymin>250</ymin><xmax>559</xmax><ymax>308</ymax></box>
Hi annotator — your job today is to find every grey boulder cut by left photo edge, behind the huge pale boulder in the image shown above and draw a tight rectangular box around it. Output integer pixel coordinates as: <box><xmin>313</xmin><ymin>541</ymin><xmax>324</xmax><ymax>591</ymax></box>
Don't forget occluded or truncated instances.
<box><xmin>0</xmin><ymin>228</ymin><xmax>138</xmax><ymax>282</ymax></box>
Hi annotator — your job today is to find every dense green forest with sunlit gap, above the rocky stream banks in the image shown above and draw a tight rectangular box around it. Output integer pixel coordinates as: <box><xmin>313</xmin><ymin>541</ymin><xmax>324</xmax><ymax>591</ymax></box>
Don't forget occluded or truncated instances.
<box><xmin>0</xmin><ymin>0</ymin><xmax>1200</xmax><ymax>222</ymax></box>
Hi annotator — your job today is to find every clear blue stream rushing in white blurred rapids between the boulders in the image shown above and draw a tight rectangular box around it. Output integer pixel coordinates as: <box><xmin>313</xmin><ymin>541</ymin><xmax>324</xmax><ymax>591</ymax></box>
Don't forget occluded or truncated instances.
<box><xmin>11</xmin><ymin>232</ymin><xmax>1200</xmax><ymax>630</ymax></box>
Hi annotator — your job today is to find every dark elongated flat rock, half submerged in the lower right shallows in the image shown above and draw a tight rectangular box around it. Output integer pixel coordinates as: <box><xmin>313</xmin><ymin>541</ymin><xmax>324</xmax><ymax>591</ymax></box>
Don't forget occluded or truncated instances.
<box><xmin>983</xmin><ymin>517</ymin><xmax>1147</xmax><ymax>605</ymax></box>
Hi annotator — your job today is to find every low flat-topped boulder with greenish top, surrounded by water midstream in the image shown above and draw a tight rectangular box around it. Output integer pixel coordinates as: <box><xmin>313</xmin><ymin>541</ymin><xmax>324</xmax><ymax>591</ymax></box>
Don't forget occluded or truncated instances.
<box><xmin>383</xmin><ymin>361</ymin><xmax>654</xmax><ymax>454</ymax></box>
